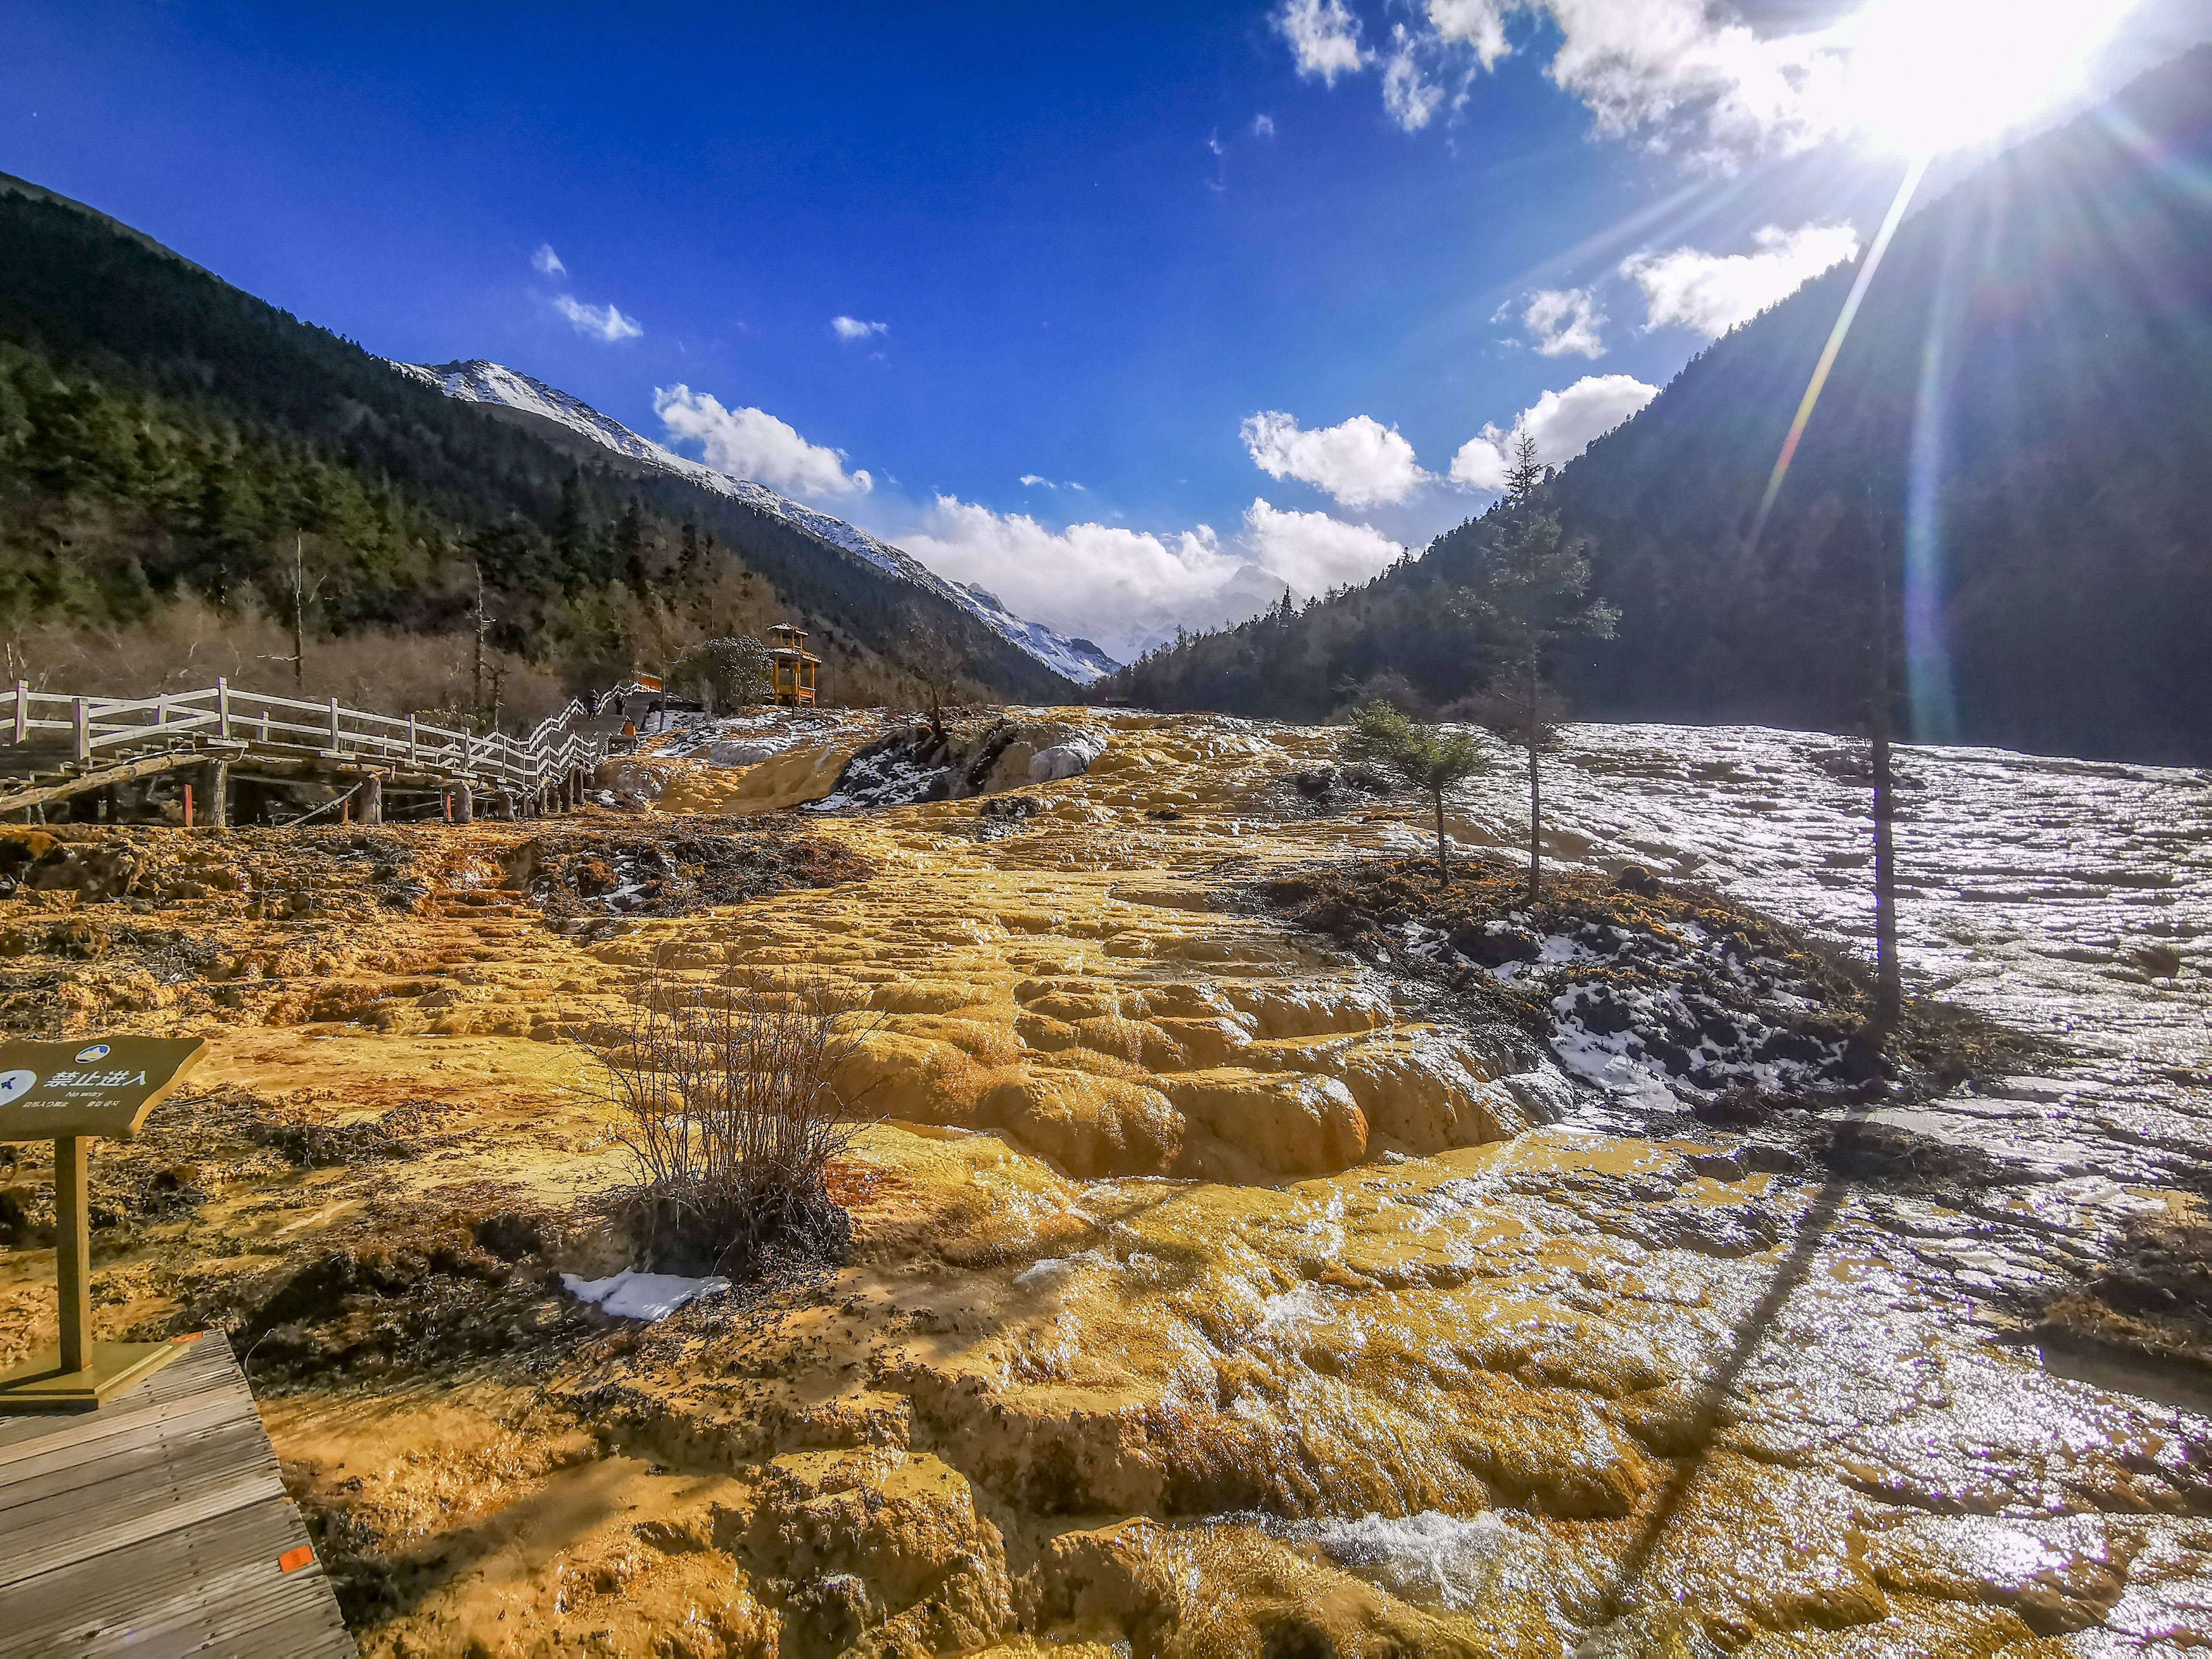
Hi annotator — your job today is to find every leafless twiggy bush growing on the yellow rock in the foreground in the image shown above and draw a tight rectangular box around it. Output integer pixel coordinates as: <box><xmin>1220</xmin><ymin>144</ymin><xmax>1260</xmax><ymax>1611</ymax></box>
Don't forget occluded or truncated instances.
<box><xmin>584</xmin><ymin>980</ymin><xmax>874</xmax><ymax>1276</ymax></box>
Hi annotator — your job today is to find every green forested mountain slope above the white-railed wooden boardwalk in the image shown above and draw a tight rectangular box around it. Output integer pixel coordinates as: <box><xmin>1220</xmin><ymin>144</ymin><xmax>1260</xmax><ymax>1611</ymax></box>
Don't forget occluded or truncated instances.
<box><xmin>0</xmin><ymin>175</ymin><xmax>1071</xmax><ymax>701</ymax></box>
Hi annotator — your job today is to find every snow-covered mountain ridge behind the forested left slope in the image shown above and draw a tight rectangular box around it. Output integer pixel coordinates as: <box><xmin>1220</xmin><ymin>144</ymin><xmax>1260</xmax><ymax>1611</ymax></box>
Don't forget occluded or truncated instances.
<box><xmin>391</xmin><ymin>358</ymin><xmax>1119</xmax><ymax>686</ymax></box>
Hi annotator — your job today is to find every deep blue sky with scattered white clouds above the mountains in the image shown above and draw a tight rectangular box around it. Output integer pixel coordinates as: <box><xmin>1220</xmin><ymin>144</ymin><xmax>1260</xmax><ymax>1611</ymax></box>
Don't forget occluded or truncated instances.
<box><xmin>0</xmin><ymin>0</ymin><xmax>2212</xmax><ymax>652</ymax></box>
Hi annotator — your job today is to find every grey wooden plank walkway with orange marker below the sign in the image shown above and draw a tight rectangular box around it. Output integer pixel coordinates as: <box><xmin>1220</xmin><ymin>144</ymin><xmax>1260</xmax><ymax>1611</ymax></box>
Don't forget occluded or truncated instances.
<box><xmin>0</xmin><ymin>1334</ymin><xmax>356</xmax><ymax>1659</ymax></box>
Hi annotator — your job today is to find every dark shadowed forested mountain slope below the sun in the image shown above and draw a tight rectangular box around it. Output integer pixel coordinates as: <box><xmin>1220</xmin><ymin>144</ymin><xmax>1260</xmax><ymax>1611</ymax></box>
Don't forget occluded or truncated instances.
<box><xmin>1102</xmin><ymin>49</ymin><xmax>2212</xmax><ymax>763</ymax></box>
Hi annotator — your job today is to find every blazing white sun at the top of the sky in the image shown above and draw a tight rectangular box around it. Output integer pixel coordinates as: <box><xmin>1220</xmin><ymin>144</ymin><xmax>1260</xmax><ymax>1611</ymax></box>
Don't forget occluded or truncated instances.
<box><xmin>1836</xmin><ymin>0</ymin><xmax>2137</xmax><ymax>155</ymax></box>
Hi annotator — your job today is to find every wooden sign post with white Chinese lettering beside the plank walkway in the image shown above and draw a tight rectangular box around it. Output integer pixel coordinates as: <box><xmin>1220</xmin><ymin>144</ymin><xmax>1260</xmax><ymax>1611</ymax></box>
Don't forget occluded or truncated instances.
<box><xmin>0</xmin><ymin>1037</ymin><xmax>208</xmax><ymax>1416</ymax></box>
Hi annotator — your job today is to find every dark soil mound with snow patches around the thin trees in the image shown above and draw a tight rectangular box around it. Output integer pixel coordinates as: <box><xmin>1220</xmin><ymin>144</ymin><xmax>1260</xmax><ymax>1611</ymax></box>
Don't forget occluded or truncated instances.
<box><xmin>1259</xmin><ymin>858</ymin><xmax>2037</xmax><ymax>1128</ymax></box>
